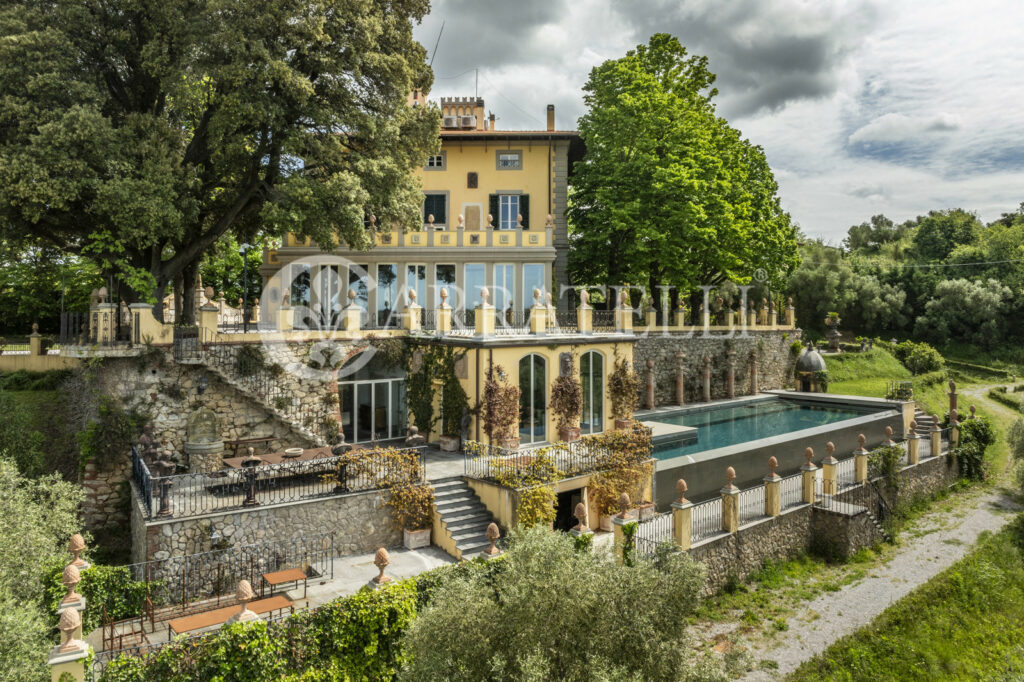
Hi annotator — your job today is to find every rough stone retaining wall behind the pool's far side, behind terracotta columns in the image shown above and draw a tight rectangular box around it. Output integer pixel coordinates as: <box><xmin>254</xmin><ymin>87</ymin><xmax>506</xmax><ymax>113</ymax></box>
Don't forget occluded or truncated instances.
<box><xmin>633</xmin><ymin>330</ymin><xmax>801</xmax><ymax>408</ymax></box>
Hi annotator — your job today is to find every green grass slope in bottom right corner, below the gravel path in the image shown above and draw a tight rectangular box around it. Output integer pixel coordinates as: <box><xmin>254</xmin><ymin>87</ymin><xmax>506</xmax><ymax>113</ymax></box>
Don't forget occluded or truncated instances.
<box><xmin>788</xmin><ymin>518</ymin><xmax>1024</xmax><ymax>682</ymax></box>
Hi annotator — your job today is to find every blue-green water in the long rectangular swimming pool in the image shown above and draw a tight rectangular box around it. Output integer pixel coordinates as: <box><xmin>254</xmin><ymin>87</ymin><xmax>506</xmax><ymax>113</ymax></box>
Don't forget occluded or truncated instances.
<box><xmin>644</xmin><ymin>399</ymin><xmax>874</xmax><ymax>460</ymax></box>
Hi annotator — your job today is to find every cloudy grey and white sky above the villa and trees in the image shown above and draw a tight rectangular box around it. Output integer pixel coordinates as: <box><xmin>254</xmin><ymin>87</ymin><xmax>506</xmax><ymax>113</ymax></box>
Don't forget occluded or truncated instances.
<box><xmin>417</xmin><ymin>0</ymin><xmax>1024</xmax><ymax>243</ymax></box>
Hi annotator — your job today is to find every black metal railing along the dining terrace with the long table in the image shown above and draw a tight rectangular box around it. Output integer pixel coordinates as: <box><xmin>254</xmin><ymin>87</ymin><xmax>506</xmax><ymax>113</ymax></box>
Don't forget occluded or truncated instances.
<box><xmin>133</xmin><ymin>449</ymin><xmax>426</xmax><ymax>518</ymax></box>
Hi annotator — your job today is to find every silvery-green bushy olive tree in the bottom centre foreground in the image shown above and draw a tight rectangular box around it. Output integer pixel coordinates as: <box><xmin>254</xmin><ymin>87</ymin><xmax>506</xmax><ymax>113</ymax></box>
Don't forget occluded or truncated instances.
<box><xmin>402</xmin><ymin>528</ymin><xmax>717</xmax><ymax>681</ymax></box>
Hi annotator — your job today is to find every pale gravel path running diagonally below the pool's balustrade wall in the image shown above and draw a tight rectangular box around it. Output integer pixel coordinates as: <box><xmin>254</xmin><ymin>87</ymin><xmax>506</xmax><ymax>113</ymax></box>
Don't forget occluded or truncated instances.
<box><xmin>742</xmin><ymin>485</ymin><xmax>1020</xmax><ymax>681</ymax></box>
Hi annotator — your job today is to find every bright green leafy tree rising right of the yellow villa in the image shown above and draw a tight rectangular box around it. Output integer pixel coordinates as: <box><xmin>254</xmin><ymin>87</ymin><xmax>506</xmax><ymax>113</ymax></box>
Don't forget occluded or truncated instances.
<box><xmin>568</xmin><ymin>34</ymin><xmax>797</xmax><ymax>303</ymax></box>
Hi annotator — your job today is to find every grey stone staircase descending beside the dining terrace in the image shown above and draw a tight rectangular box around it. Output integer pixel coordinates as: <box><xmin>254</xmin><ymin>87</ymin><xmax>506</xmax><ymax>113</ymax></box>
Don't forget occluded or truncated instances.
<box><xmin>430</xmin><ymin>477</ymin><xmax>495</xmax><ymax>559</ymax></box>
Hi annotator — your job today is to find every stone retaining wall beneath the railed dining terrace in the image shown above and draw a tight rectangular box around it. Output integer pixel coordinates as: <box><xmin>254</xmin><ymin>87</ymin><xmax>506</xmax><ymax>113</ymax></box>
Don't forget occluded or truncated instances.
<box><xmin>131</xmin><ymin>483</ymin><xmax>401</xmax><ymax>562</ymax></box>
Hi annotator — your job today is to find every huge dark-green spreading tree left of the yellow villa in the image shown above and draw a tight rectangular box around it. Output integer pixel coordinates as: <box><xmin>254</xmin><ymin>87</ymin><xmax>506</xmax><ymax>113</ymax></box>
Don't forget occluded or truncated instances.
<box><xmin>0</xmin><ymin>0</ymin><xmax>439</xmax><ymax>319</ymax></box>
